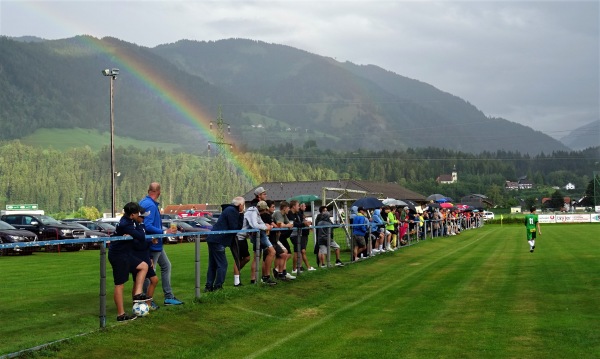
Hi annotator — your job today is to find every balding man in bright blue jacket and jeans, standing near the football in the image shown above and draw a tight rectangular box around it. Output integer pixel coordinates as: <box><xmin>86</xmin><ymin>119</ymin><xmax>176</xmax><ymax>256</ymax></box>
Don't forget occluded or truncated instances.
<box><xmin>140</xmin><ymin>182</ymin><xmax>183</xmax><ymax>308</ymax></box>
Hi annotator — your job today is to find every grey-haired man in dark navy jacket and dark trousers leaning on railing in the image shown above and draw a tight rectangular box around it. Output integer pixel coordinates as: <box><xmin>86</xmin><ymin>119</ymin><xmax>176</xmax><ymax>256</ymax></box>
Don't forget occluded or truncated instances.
<box><xmin>205</xmin><ymin>197</ymin><xmax>245</xmax><ymax>292</ymax></box>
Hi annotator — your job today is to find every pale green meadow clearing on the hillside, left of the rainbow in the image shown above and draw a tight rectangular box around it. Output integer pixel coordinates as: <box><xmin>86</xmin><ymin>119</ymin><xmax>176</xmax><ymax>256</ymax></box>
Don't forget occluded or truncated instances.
<box><xmin>21</xmin><ymin>128</ymin><xmax>181</xmax><ymax>151</ymax></box>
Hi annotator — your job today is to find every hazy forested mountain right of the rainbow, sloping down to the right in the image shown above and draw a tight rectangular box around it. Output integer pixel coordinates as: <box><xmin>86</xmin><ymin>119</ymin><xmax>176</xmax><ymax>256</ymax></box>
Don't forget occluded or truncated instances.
<box><xmin>153</xmin><ymin>39</ymin><xmax>567</xmax><ymax>154</ymax></box>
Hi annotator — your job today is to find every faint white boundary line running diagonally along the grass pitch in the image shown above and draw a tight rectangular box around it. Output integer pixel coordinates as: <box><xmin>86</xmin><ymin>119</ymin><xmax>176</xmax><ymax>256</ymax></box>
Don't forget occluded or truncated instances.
<box><xmin>245</xmin><ymin>234</ymin><xmax>487</xmax><ymax>359</ymax></box>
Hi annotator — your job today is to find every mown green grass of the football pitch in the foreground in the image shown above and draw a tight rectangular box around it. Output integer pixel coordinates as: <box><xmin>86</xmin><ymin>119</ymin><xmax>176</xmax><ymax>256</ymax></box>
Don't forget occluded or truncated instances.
<box><xmin>0</xmin><ymin>224</ymin><xmax>600</xmax><ymax>358</ymax></box>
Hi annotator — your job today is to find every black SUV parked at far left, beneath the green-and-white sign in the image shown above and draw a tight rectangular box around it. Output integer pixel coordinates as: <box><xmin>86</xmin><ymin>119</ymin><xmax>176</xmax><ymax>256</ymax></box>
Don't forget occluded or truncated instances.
<box><xmin>0</xmin><ymin>214</ymin><xmax>85</xmax><ymax>251</ymax></box>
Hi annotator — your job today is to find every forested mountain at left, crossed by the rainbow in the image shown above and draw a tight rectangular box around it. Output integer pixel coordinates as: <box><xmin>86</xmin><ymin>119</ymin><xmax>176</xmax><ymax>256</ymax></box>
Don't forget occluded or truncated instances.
<box><xmin>0</xmin><ymin>36</ymin><xmax>251</xmax><ymax>149</ymax></box>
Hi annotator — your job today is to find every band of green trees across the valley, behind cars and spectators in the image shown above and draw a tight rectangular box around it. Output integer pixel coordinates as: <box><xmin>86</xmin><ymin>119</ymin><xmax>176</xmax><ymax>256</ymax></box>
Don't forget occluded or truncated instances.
<box><xmin>0</xmin><ymin>141</ymin><xmax>600</xmax><ymax>213</ymax></box>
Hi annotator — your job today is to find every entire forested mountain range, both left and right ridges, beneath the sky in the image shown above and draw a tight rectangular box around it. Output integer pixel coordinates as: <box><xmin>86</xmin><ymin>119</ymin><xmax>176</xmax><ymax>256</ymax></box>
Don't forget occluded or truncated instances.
<box><xmin>0</xmin><ymin>36</ymin><xmax>568</xmax><ymax>154</ymax></box>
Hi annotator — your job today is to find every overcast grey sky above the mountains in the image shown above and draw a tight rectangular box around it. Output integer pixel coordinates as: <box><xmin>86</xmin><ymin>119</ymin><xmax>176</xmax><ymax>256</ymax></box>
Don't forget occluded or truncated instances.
<box><xmin>0</xmin><ymin>0</ymin><xmax>600</xmax><ymax>141</ymax></box>
